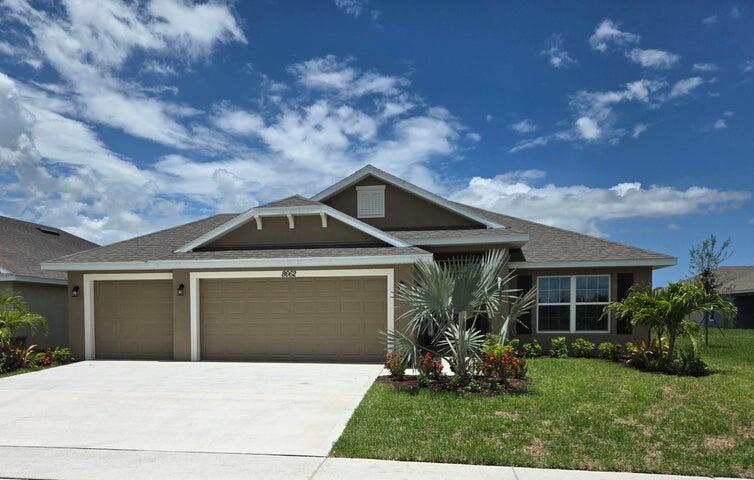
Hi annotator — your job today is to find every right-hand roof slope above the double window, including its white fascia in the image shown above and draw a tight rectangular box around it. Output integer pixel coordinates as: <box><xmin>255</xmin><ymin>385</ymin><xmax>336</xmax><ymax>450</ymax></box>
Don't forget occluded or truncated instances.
<box><xmin>458</xmin><ymin>205</ymin><xmax>678</xmax><ymax>268</ymax></box>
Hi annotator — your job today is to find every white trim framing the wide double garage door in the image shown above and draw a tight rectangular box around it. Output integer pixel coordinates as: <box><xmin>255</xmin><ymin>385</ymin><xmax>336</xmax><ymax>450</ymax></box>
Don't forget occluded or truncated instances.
<box><xmin>189</xmin><ymin>268</ymin><xmax>395</xmax><ymax>362</ymax></box>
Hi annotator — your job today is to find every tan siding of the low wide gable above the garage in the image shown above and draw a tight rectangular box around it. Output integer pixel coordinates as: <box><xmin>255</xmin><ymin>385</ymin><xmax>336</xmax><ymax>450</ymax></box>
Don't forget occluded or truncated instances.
<box><xmin>207</xmin><ymin>215</ymin><xmax>384</xmax><ymax>248</ymax></box>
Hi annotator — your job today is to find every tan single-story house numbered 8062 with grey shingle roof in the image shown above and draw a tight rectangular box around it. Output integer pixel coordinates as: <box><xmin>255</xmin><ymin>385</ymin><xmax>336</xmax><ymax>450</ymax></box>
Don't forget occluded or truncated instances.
<box><xmin>44</xmin><ymin>166</ymin><xmax>676</xmax><ymax>361</ymax></box>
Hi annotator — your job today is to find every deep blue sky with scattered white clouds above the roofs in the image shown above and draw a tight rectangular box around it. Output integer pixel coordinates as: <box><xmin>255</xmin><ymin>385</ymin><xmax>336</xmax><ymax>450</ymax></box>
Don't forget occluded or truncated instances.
<box><xmin>0</xmin><ymin>0</ymin><xmax>754</xmax><ymax>283</ymax></box>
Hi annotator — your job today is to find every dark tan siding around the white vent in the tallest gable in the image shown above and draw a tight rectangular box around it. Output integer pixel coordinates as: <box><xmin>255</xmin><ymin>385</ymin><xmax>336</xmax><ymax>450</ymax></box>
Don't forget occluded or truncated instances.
<box><xmin>324</xmin><ymin>176</ymin><xmax>480</xmax><ymax>230</ymax></box>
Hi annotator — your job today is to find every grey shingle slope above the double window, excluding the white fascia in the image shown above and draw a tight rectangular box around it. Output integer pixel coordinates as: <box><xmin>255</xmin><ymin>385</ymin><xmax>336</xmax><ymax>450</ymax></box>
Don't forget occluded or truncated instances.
<box><xmin>456</xmin><ymin>205</ymin><xmax>675</xmax><ymax>262</ymax></box>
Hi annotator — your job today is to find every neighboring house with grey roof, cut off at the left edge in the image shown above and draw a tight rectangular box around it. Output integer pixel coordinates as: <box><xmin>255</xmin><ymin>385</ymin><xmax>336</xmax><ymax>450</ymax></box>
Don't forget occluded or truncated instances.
<box><xmin>0</xmin><ymin>216</ymin><xmax>98</xmax><ymax>348</ymax></box>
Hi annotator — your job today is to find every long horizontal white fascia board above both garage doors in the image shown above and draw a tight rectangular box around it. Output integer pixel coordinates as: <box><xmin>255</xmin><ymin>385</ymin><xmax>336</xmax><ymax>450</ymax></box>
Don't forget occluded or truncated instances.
<box><xmin>42</xmin><ymin>253</ymin><xmax>433</xmax><ymax>272</ymax></box>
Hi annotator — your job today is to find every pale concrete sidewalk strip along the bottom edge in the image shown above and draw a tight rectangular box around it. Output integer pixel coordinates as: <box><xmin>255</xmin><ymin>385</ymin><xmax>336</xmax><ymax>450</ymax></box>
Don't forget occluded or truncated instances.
<box><xmin>0</xmin><ymin>446</ymin><xmax>744</xmax><ymax>480</ymax></box>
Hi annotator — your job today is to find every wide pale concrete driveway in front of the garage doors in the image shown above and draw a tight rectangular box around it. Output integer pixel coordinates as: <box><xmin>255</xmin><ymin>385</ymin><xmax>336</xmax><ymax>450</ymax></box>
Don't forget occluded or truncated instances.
<box><xmin>0</xmin><ymin>361</ymin><xmax>382</xmax><ymax>457</ymax></box>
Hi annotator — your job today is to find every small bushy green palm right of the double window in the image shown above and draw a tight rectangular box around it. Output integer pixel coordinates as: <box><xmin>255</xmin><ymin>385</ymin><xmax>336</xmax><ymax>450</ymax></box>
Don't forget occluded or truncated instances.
<box><xmin>605</xmin><ymin>282</ymin><xmax>737</xmax><ymax>365</ymax></box>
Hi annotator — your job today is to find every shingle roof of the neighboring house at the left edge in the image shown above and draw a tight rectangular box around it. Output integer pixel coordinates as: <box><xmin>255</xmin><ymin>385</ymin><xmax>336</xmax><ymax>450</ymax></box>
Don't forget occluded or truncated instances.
<box><xmin>0</xmin><ymin>216</ymin><xmax>97</xmax><ymax>280</ymax></box>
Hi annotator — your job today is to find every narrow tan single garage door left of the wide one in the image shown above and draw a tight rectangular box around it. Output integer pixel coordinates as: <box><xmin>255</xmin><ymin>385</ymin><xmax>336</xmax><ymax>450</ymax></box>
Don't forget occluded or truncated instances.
<box><xmin>94</xmin><ymin>280</ymin><xmax>173</xmax><ymax>360</ymax></box>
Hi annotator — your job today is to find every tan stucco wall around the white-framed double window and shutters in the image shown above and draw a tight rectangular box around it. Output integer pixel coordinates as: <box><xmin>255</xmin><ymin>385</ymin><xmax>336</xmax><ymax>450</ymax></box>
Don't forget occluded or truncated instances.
<box><xmin>518</xmin><ymin>268</ymin><xmax>652</xmax><ymax>348</ymax></box>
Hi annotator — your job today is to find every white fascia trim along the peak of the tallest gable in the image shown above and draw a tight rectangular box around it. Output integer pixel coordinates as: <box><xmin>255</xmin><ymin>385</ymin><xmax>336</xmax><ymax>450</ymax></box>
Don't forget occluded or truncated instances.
<box><xmin>312</xmin><ymin>165</ymin><xmax>505</xmax><ymax>228</ymax></box>
